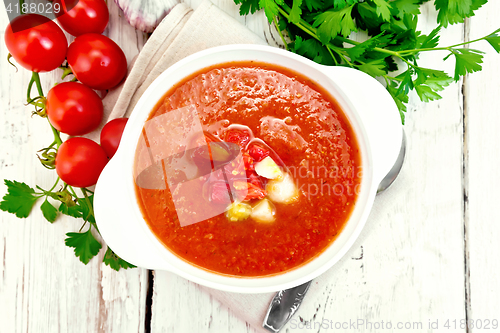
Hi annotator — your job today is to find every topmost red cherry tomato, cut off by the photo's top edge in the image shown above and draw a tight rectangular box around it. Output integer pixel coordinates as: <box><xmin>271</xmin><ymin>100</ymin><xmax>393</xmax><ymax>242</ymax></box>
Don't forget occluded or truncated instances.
<box><xmin>54</xmin><ymin>0</ymin><xmax>109</xmax><ymax>36</ymax></box>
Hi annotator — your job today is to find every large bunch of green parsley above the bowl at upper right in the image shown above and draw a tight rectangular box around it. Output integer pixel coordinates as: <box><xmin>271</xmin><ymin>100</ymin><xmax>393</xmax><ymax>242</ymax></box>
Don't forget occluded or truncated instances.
<box><xmin>234</xmin><ymin>0</ymin><xmax>500</xmax><ymax>124</ymax></box>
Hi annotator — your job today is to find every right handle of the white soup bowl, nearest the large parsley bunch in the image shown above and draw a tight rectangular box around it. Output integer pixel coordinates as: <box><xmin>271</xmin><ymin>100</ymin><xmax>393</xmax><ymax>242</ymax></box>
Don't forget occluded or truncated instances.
<box><xmin>320</xmin><ymin>66</ymin><xmax>403</xmax><ymax>185</ymax></box>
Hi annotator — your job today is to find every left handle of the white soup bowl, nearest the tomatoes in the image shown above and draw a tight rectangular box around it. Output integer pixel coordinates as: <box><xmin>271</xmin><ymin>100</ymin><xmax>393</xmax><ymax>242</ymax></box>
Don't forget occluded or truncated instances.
<box><xmin>94</xmin><ymin>153</ymin><xmax>169</xmax><ymax>270</ymax></box>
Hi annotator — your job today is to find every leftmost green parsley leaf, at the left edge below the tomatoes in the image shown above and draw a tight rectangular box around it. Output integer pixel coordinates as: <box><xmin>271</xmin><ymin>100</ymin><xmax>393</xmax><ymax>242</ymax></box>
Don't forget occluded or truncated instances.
<box><xmin>0</xmin><ymin>179</ymin><xmax>41</xmax><ymax>218</ymax></box>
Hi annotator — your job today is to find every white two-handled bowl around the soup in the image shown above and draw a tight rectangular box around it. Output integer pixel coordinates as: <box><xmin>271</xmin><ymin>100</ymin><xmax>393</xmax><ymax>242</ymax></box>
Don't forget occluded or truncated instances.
<box><xmin>94</xmin><ymin>45</ymin><xmax>402</xmax><ymax>293</ymax></box>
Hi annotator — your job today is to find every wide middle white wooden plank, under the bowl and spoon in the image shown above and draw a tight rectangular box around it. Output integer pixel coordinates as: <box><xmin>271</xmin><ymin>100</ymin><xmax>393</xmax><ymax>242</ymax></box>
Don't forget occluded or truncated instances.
<box><xmin>152</xmin><ymin>2</ymin><xmax>465</xmax><ymax>332</ymax></box>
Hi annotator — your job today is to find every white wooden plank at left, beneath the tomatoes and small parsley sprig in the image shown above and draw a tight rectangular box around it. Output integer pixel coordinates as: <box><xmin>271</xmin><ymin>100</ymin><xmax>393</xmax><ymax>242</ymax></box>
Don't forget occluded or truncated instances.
<box><xmin>0</xmin><ymin>1</ymin><xmax>148</xmax><ymax>333</ymax></box>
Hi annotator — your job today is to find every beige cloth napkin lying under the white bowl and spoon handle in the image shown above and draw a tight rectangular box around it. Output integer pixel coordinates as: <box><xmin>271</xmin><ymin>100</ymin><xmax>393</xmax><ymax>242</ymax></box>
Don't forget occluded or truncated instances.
<box><xmin>89</xmin><ymin>0</ymin><xmax>340</xmax><ymax>332</ymax></box>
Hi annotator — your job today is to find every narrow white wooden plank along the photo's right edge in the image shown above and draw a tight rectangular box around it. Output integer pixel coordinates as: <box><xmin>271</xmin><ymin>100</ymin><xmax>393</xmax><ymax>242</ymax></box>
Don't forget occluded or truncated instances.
<box><xmin>465</xmin><ymin>1</ymin><xmax>500</xmax><ymax>332</ymax></box>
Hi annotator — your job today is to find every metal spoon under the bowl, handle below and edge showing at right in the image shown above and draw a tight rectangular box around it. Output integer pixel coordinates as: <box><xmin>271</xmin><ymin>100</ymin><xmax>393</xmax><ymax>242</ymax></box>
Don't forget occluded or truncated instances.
<box><xmin>262</xmin><ymin>131</ymin><xmax>406</xmax><ymax>333</ymax></box>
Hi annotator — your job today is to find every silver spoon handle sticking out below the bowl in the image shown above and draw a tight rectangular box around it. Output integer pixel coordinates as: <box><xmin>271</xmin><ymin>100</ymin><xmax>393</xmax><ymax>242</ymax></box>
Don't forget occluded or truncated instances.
<box><xmin>262</xmin><ymin>281</ymin><xmax>311</xmax><ymax>333</ymax></box>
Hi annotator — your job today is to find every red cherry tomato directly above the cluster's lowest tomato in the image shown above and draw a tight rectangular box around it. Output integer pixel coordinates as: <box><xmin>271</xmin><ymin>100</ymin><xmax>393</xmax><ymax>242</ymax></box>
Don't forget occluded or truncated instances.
<box><xmin>45</xmin><ymin>82</ymin><xmax>103</xmax><ymax>135</ymax></box>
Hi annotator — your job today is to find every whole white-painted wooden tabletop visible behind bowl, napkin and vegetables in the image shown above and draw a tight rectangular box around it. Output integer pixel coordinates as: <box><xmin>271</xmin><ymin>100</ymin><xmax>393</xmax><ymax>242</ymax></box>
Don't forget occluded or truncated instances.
<box><xmin>0</xmin><ymin>0</ymin><xmax>500</xmax><ymax>333</ymax></box>
